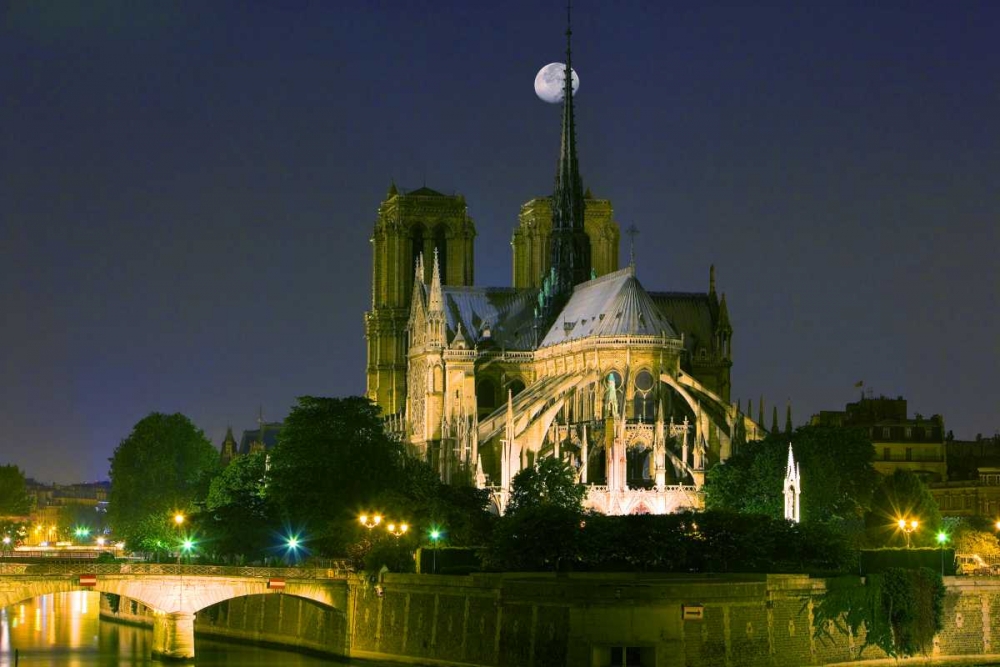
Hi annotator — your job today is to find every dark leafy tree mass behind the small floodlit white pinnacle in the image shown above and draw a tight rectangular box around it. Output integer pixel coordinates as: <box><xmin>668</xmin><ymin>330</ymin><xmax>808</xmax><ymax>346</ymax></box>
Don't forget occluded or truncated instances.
<box><xmin>705</xmin><ymin>426</ymin><xmax>879</xmax><ymax>522</ymax></box>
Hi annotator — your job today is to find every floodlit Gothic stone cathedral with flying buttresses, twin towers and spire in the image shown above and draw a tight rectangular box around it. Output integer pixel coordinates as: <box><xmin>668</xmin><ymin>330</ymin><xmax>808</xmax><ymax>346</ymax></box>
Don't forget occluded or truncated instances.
<box><xmin>365</xmin><ymin>19</ymin><xmax>763</xmax><ymax>514</ymax></box>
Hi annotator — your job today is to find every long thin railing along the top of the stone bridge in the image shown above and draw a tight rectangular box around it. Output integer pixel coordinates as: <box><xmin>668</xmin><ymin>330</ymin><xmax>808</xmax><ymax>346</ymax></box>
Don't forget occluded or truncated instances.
<box><xmin>0</xmin><ymin>561</ymin><xmax>354</xmax><ymax>579</ymax></box>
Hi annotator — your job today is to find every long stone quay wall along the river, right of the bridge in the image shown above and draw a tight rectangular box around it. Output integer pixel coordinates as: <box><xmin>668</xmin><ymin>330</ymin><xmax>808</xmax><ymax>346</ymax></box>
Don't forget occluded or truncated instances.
<box><xmin>95</xmin><ymin>574</ymin><xmax>1000</xmax><ymax>667</ymax></box>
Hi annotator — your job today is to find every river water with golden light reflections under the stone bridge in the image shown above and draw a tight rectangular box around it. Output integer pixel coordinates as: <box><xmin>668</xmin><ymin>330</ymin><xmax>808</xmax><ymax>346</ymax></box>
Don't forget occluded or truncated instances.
<box><xmin>0</xmin><ymin>591</ymin><xmax>398</xmax><ymax>667</ymax></box>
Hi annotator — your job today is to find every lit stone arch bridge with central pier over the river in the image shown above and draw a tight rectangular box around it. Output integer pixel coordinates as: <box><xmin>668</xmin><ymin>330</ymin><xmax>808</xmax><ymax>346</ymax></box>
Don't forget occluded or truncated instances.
<box><xmin>0</xmin><ymin>563</ymin><xmax>349</xmax><ymax>659</ymax></box>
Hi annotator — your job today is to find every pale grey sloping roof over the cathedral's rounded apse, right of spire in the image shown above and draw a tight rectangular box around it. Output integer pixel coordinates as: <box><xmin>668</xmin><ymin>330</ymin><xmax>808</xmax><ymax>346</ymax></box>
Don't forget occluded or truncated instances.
<box><xmin>540</xmin><ymin>266</ymin><xmax>678</xmax><ymax>347</ymax></box>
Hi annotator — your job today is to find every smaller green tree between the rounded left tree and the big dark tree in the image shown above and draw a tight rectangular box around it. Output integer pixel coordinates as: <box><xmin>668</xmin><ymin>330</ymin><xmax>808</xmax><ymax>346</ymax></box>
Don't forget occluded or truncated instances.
<box><xmin>199</xmin><ymin>452</ymin><xmax>277</xmax><ymax>560</ymax></box>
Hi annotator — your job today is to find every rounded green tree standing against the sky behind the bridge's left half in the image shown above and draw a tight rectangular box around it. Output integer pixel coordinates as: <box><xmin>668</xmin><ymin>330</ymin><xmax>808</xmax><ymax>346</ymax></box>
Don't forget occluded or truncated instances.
<box><xmin>108</xmin><ymin>412</ymin><xmax>219</xmax><ymax>551</ymax></box>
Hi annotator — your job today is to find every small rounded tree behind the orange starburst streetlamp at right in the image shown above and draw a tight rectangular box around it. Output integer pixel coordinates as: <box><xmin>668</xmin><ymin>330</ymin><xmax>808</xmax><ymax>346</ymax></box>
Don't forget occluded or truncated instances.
<box><xmin>865</xmin><ymin>469</ymin><xmax>942</xmax><ymax>546</ymax></box>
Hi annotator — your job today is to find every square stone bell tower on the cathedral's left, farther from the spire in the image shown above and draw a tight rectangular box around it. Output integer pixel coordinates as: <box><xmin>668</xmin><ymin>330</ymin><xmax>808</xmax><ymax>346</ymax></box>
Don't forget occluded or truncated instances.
<box><xmin>365</xmin><ymin>184</ymin><xmax>476</xmax><ymax>415</ymax></box>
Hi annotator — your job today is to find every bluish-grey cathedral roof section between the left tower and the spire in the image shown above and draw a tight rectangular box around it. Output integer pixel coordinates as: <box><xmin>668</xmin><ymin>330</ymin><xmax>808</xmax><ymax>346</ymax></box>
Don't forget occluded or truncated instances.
<box><xmin>442</xmin><ymin>285</ymin><xmax>537</xmax><ymax>350</ymax></box>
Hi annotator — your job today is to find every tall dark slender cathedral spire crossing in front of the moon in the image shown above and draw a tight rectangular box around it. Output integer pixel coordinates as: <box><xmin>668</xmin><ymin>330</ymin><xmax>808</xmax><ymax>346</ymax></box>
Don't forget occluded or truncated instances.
<box><xmin>550</xmin><ymin>3</ymin><xmax>590</xmax><ymax>296</ymax></box>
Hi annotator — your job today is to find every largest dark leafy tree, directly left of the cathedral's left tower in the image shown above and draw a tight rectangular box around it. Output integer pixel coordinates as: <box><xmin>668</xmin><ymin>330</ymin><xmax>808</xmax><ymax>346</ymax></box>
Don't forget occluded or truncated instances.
<box><xmin>269</xmin><ymin>396</ymin><xmax>404</xmax><ymax>555</ymax></box>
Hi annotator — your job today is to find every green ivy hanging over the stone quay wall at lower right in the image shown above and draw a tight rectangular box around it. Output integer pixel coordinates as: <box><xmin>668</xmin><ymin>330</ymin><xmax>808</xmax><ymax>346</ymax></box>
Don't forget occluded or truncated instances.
<box><xmin>813</xmin><ymin>568</ymin><xmax>944</xmax><ymax>658</ymax></box>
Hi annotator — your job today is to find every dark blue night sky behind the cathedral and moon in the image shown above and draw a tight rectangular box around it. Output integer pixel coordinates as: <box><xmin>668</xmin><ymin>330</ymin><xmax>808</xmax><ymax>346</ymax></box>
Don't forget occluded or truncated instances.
<box><xmin>0</xmin><ymin>0</ymin><xmax>1000</xmax><ymax>482</ymax></box>
